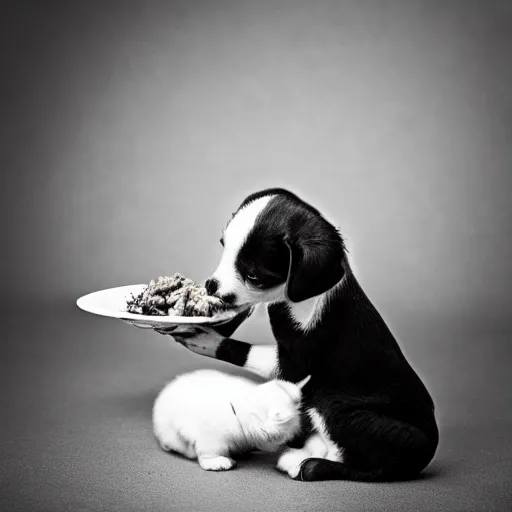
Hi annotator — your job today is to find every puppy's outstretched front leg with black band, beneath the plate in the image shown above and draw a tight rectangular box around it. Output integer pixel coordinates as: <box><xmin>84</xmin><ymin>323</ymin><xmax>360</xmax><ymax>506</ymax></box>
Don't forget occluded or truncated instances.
<box><xmin>158</xmin><ymin>325</ymin><xmax>277</xmax><ymax>379</ymax></box>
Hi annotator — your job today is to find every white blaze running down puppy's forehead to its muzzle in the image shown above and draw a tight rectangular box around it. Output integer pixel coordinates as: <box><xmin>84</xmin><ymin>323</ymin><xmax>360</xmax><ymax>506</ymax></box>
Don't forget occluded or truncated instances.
<box><xmin>213</xmin><ymin>196</ymin><xmax>274</xmax><ymax>294</ymax></box>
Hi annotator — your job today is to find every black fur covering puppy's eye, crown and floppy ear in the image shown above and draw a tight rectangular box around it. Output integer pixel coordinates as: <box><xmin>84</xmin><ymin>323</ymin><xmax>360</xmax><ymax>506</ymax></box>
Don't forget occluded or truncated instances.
<box><xmin>235</xmin><ymin>189</ymin><xmax>345</xmax><ymax>301</ymax></box>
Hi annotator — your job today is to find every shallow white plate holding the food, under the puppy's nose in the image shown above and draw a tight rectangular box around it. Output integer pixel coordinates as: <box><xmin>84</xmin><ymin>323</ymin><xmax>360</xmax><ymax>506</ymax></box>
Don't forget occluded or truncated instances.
<box><xmin>76</xmin><ymin>284</ymin><xmax>249</xmax><ymax>329</ymax></box>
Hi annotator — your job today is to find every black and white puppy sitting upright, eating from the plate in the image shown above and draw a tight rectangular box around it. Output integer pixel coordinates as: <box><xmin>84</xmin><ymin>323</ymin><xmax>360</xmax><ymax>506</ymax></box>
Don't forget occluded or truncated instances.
<box><xmin>166</xmin><ymin>189</ymin><xmax>439</xmax><ymax>481</ymax></box>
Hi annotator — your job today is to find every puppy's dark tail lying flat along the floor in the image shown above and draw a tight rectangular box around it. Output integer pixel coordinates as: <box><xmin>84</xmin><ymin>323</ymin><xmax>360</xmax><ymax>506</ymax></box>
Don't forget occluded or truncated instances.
<box><xmin>296</xmin><ymin>458</ymin><xmax>415</xmax><ymax>482</ymax></box>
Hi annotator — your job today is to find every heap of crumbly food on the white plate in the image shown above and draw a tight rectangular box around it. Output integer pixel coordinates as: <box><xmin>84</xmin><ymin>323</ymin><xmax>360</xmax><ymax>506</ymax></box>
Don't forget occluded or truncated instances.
<box><xmin>126</xmin><ymin>273</ymin><xmax>230</xmax><ymax>316</ymax></box>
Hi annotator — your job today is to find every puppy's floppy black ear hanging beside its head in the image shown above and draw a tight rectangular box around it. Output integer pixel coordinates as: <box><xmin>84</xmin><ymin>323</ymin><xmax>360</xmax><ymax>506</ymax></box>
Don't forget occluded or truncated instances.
<box><xmin>284</xmin><ymin>236</ymin><xmax>345</xmax><ymax>302</ymax></box>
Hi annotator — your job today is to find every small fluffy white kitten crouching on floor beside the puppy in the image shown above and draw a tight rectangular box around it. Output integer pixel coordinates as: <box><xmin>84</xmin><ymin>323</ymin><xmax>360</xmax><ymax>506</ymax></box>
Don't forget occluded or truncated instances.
<box><xmin>153</xmin><ymin>370</ymin><xmax>310</xmax><ymax>471</ymax></box>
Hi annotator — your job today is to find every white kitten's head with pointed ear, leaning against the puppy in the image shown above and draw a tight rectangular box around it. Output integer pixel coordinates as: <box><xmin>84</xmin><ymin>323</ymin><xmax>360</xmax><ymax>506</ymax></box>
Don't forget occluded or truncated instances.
<box><xmin>247</xmin><ymin>375</ymin><xmax>311</xmax><ymax>443</ymax></box>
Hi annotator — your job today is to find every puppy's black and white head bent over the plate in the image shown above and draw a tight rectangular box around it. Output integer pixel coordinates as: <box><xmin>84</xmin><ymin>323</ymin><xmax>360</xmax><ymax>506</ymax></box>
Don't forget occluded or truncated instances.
<box><xmin>206</xmin><ymin>189</ymin><xmax>345</xmax><ymax>306</ymax></box>
